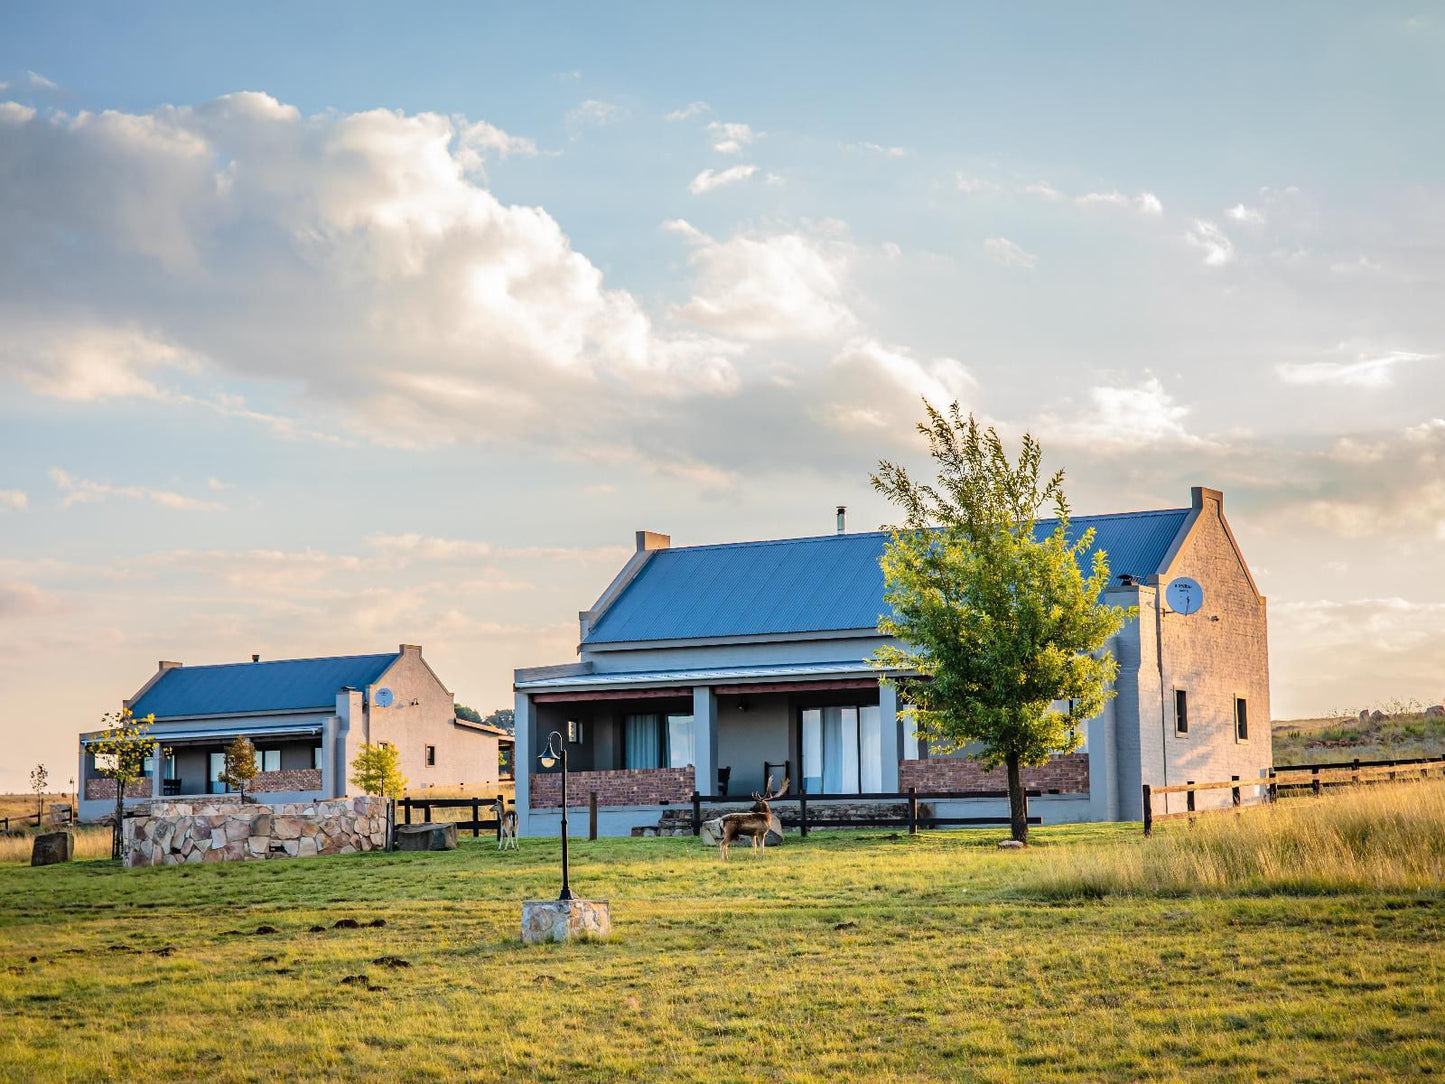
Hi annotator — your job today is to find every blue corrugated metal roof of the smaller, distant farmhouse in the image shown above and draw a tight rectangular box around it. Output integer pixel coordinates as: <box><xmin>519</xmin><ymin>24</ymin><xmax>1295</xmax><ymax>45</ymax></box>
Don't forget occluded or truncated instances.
<box><xmin>130</xmin><ymin>652</ymin><xmax>400</xmax><ymax>720</ymax></box>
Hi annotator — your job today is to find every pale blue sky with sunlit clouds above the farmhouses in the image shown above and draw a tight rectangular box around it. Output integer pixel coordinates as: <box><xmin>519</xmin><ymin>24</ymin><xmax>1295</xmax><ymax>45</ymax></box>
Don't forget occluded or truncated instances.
<box><xmin>0</xmin><ymin>3</ymin><xmax>1445</xmax><ymax>791</ymax></box>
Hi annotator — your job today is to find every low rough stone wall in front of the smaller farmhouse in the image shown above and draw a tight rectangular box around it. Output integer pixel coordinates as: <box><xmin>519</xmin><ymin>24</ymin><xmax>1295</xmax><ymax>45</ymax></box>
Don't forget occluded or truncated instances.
<box><xmin>124</xmin><ymin>795</ymin><xmax>386</xmax><ymax>867</ymax></box>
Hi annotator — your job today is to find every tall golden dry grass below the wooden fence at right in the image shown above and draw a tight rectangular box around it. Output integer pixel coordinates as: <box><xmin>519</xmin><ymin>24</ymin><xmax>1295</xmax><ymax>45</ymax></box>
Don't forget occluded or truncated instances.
<box><xmin>1029</xmin><ymin>780</ymin><xmax>1445</xmax><ymax>896</ymax></box>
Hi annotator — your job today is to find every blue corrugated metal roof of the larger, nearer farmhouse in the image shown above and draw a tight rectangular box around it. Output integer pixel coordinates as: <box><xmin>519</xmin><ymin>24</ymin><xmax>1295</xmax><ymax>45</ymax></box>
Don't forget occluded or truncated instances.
<box><xmin>584</xmin><ymin>509</ymin><xmax>1189</xmax><ymax>643</ymax></box>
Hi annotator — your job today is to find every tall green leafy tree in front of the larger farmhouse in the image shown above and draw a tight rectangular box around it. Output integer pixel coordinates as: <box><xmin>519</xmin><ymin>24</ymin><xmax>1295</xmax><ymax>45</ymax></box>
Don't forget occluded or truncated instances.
<box><xmin>870</xmin><ymin>402</ymin><xmax>1134</xmax><ymax>843</ymax></box>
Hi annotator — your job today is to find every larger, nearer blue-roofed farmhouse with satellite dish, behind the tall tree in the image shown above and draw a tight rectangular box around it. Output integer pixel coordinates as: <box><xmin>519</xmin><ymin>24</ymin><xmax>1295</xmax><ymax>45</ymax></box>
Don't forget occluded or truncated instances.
<box><xmin>514</xmin><ymin>487</ymin><xmax>1272</xmax><ymax>834</ymax></box>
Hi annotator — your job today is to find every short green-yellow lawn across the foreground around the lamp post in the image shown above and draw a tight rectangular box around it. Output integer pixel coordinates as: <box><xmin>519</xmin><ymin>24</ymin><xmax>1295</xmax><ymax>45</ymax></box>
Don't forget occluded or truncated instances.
<box><xmin>0</xmin><ymin>825</ymin><xmax>1445</xmax><ymax>1083</ymax></box>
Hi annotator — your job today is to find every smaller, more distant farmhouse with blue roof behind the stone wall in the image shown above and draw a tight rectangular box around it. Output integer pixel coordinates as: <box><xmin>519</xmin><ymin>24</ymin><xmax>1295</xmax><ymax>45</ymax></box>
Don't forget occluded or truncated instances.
<box><xmin>79</xmin><ymin>643</ymin><xmax>509</xmax><ymax>818</ymax></box>
